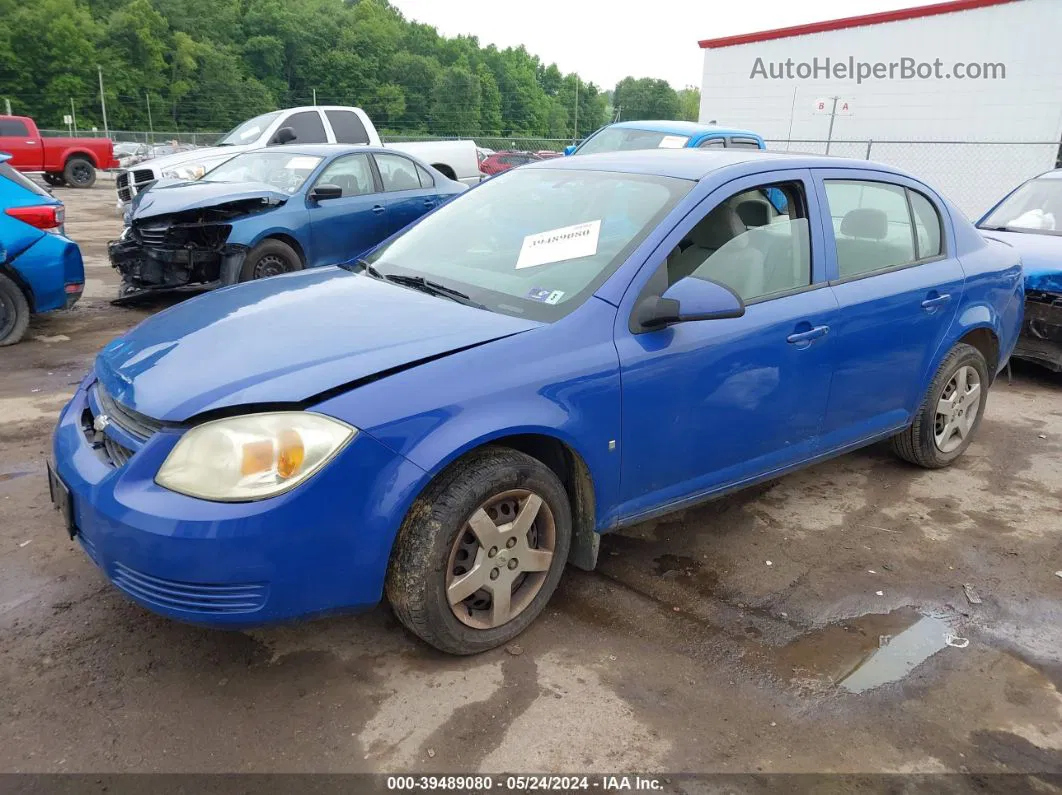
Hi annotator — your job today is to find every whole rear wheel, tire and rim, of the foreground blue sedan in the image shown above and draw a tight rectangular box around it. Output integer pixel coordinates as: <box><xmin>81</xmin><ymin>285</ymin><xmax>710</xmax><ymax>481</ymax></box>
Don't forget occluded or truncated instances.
<box><xmin>892</xmin><ymin>343</ymin><xmax>989</xmax><ymax>469</ymax></box>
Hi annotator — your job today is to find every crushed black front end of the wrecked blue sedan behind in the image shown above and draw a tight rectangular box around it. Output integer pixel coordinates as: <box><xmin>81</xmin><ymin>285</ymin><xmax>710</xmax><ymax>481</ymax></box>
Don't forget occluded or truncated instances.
<box><xmin>107</xmin><ymin>210</ymin><xmax>247</xmax><ymax>301</ymax></box>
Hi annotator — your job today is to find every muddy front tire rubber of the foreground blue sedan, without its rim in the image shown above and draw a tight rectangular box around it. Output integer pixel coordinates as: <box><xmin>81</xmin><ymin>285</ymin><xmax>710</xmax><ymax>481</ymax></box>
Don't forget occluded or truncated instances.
<box><xmin>386</xmin><ymin>447</ymin><xmax>571</xmax><ymax>655</ymax></box>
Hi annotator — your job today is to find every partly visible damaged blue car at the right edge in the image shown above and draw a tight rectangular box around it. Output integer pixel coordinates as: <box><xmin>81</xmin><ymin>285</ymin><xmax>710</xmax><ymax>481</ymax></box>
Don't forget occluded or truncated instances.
<box><xmin>977</xmin><ymin>169</ymin><xmax>1062</xmax><ymax>373</ymax></box>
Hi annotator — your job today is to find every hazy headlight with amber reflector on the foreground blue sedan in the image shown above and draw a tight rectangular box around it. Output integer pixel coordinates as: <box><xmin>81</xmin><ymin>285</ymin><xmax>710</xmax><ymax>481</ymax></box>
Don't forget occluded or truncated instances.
<box><xmin>155</xmin><ymin>412</ymin><xmax>358</xmax><ymax>502</ymax></box>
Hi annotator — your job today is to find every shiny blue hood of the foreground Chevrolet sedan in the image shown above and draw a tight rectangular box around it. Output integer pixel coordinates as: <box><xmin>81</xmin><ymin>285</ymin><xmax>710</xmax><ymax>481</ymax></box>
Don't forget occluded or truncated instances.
<box><xmin>96</xmin><ymin>267</ymin><xmax>541</xmax><ymax>421</ymax></box>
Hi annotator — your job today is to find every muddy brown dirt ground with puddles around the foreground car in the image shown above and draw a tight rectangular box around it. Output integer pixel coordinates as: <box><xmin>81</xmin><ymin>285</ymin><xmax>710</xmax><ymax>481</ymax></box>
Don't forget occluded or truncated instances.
<box><xmin>0</xmin><ymin>184</ymin><xmax>1062</xmax><ymax>773</ymax></box>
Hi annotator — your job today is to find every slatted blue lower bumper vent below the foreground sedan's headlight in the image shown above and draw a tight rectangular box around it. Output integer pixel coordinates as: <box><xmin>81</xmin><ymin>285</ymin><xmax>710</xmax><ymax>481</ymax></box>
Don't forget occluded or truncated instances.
<box><xmin>113</xmin><ymin>561</ymin><xmax>269</xmax><ymax>615</ymax></box>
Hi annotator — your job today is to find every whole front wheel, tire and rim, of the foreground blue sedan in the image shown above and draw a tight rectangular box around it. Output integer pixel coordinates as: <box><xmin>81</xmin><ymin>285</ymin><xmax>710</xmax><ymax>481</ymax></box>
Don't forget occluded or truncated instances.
<box><xmin>387</xmin><ymin>448</ymin><xmax>571</xmax><ymax>654</ymax></box>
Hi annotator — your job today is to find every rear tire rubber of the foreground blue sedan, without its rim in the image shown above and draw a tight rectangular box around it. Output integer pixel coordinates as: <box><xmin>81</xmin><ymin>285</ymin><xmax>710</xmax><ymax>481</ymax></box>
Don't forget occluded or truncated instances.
<box><xmin>892</xmin><ymin>343</ymin><xmax>991</xmax><ymax>469</ymax></box>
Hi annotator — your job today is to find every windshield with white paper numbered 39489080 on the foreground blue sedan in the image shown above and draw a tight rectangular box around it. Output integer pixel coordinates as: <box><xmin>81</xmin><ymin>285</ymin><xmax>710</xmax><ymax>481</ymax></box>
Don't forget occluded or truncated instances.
<box><xmin>367</xmin><ymin>168</ymin><xmax>696</xmax><ymax>322</ymax></box>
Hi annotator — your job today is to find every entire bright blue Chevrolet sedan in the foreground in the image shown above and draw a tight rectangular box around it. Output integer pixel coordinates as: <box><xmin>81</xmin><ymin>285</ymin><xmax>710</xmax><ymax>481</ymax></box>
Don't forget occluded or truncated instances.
<box><xmin>50</xmin><ymin>151</ymin><xmax>1023</xmax><ymax>654</ymax></box>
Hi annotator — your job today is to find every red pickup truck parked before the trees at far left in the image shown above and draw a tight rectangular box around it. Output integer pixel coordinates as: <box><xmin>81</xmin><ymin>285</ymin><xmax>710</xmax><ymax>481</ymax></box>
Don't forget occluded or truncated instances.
<box><xmin>0</xmin><ymin>116</ymin><xmax>118</xmax><ymax>188</ymax></box>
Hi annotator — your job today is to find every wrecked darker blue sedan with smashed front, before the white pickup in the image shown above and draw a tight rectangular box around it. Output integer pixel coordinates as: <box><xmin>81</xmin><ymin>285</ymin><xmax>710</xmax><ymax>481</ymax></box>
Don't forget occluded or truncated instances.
<box><xmin>108</xmin><ymin>144</ymin><xmax>467</xmax><ymax>298</ymax></box>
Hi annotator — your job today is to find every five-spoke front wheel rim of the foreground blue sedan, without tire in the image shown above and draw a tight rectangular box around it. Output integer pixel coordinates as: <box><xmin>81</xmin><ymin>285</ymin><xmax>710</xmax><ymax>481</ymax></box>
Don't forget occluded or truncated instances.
<box><xmin>446</xmin><ymin>489</ymin><xmax>556</xmax><ymax>629</ymax></box>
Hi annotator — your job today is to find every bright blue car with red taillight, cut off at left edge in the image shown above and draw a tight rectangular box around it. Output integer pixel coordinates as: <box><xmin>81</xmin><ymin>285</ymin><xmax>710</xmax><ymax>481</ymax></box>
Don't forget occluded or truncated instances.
<box><xmin>0</xmin><ymin>153</ymin><xmax>85</xmax><ymax>347</ymax></box>
